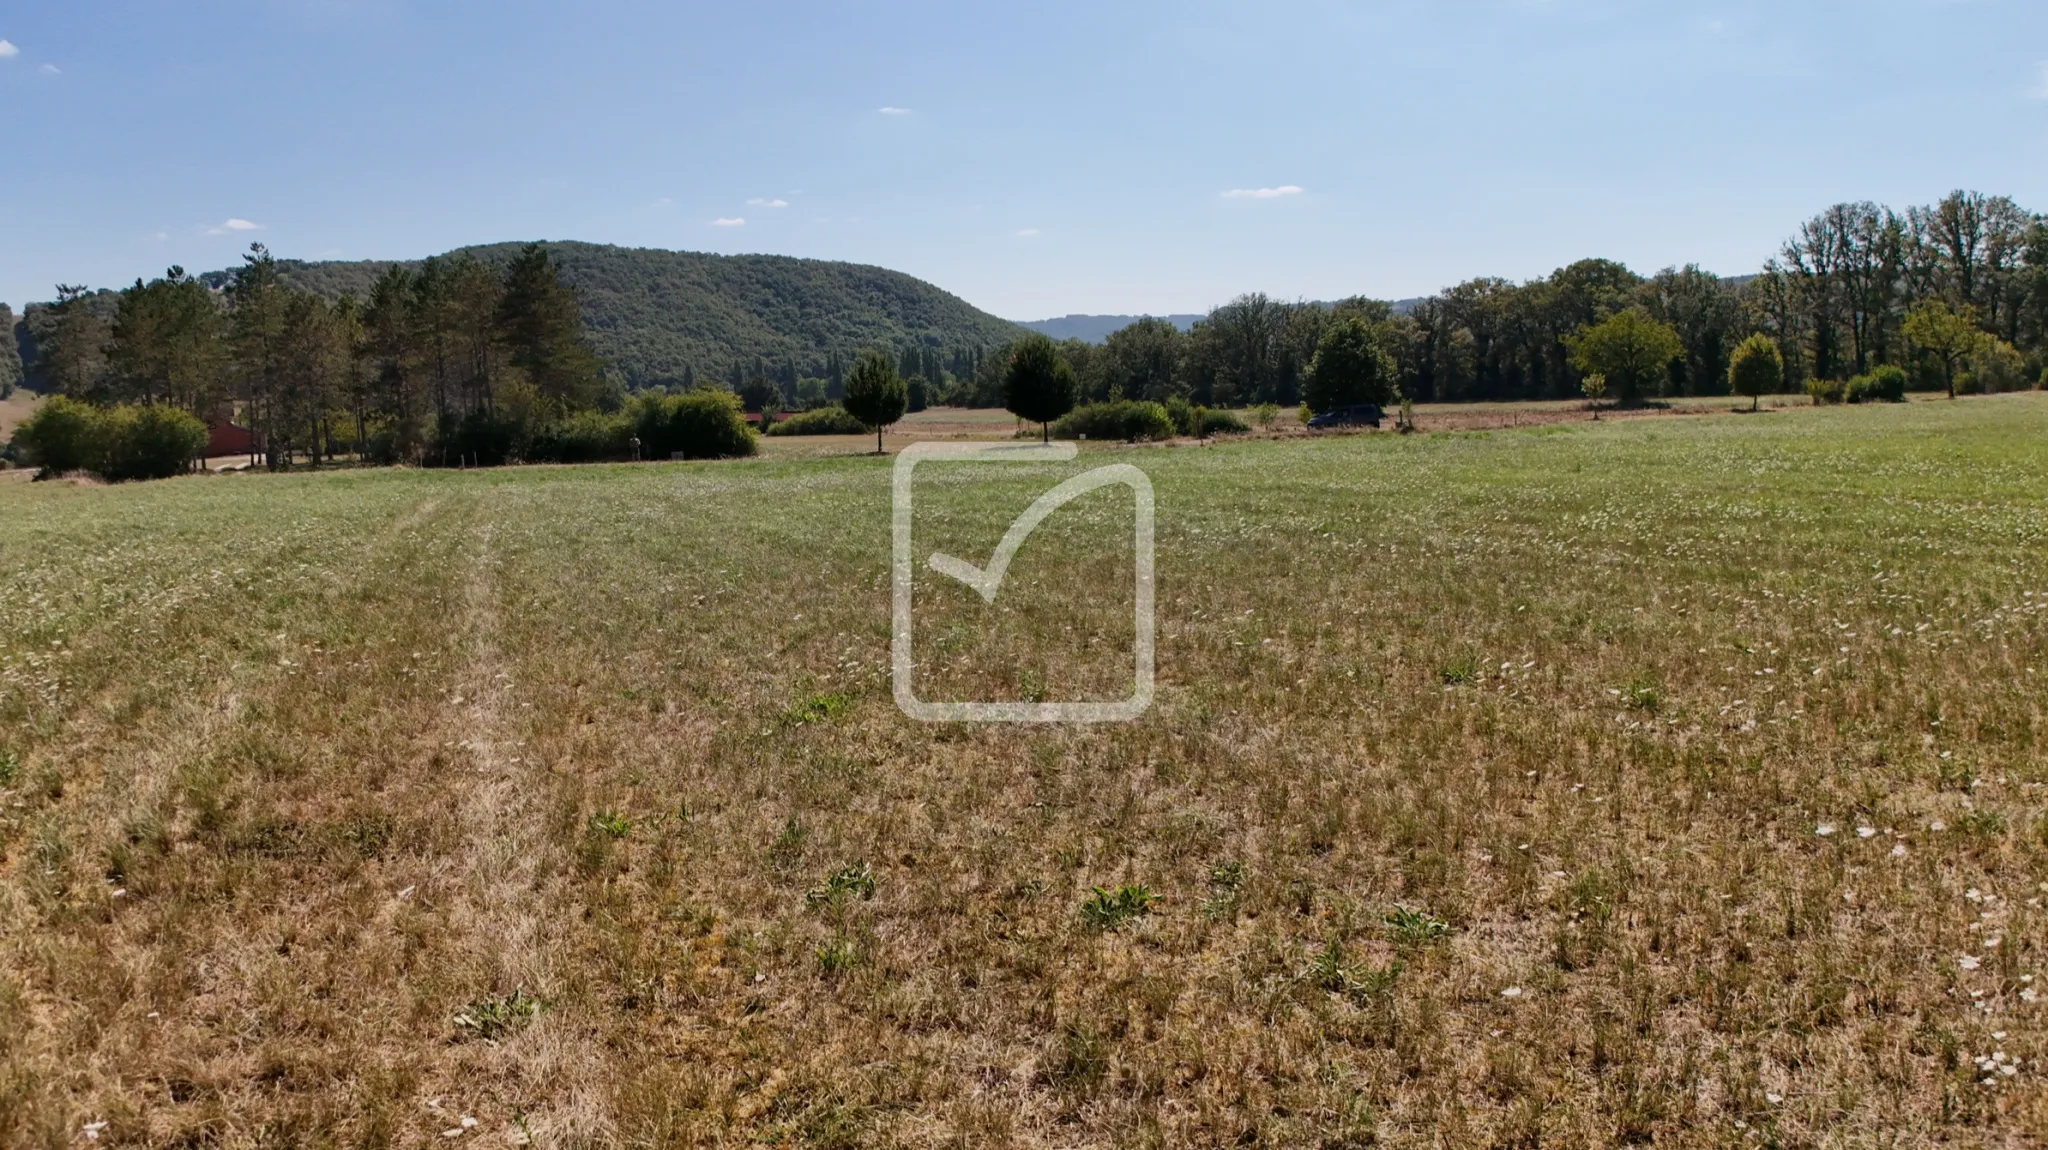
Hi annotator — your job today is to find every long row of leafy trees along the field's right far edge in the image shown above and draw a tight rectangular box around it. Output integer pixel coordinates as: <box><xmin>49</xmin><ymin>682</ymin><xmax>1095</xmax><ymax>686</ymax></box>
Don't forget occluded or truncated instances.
<box><xmin>819</xmin><ymin>192</ymin><xmax>2048</xmax><ymax>407</ymax></box>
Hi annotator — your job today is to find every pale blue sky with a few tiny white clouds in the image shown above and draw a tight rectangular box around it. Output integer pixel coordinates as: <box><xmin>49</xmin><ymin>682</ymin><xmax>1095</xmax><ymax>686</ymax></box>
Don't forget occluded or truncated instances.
<box><xmin>0</xmin><ymin>0</ymin><xmax>2048</xmax><ymax>319</ymax></box>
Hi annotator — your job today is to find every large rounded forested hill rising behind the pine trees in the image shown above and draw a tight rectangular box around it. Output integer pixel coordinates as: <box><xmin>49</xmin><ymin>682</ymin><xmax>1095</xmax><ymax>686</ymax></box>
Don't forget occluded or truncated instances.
<box><xmin>203</xmin><ymin>241</ymin><xmax>1022</xmax><ymax>387</ymax></box>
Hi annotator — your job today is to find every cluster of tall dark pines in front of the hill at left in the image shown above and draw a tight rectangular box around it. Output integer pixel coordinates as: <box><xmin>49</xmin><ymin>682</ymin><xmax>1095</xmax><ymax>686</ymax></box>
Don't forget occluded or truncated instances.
<box><xmin>19</xmin><ymin>244</ymin><xmax>618</xmax><ymax>467</ymax></box>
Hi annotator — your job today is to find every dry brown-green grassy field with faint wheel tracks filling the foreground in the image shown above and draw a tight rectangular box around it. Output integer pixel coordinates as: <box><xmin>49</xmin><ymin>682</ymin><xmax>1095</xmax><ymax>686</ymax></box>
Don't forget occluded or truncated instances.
<box><xmin>0</xmin><ymin>395</ymin><xmax>2048</xmax><ymax>1148</ymax></box>
